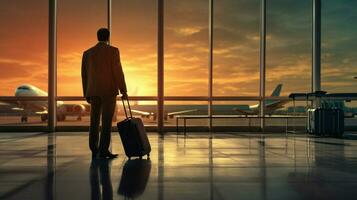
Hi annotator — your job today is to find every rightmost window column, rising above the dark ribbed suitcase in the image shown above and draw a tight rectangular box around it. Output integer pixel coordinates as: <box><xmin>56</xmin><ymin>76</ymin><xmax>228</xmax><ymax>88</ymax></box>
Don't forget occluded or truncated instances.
<box><xmin>312</xmin><ymin>0</ymin><xmax>321</xmax><ymax>107</ymax></box>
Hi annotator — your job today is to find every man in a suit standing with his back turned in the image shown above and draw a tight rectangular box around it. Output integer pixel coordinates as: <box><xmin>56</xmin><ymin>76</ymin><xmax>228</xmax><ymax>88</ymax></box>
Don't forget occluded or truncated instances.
<box><xmin>82</xmin><ymin>28</ymin><xmax>128</xmax><ymax>158</ymax></box>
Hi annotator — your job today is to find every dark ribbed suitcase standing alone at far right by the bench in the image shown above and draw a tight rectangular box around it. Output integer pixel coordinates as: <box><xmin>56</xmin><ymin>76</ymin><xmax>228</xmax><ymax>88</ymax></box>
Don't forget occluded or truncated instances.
<box><xmin>307</xmin><ymin>108</ymin><xmax>344</xmax><ymax>137</ymax></box>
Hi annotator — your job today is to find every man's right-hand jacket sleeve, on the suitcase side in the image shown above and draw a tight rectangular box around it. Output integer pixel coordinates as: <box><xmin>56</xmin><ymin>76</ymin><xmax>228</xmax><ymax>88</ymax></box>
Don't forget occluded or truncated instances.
<box><xmin>113</xmin><ymin>49</ymin><xmax>127</xmax><ymax>96</ymax></box>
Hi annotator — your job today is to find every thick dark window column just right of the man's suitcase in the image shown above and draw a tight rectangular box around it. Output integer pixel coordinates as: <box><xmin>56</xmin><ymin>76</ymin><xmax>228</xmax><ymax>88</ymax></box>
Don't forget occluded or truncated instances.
<box><xmin>157</xmin><ymin>0</ymin><xmax>164</xmax><ymax>134</ymax></box>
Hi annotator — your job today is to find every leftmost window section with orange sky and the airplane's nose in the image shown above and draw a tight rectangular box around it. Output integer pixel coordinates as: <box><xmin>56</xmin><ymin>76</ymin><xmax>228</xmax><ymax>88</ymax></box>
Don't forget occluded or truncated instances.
<box><xmin>0</xmin><ymin>0</ymin><xmax>48</xmax><ymax>127</ymax></box>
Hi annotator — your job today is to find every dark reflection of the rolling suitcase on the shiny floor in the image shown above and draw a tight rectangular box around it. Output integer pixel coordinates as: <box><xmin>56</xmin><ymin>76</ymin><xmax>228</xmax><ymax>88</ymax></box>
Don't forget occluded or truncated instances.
<box><xmin>118</xmin><ymin>159</ymin><xmax>151</xmax><ymax>198</ymax></box>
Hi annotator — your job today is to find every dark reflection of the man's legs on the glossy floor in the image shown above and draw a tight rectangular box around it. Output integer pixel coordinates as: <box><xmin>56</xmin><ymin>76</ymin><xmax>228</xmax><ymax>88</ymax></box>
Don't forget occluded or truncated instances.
<box><xmin>89</xmin><ymin>159</ymin><xmax>113</xmax><ymax>200</ymax></box>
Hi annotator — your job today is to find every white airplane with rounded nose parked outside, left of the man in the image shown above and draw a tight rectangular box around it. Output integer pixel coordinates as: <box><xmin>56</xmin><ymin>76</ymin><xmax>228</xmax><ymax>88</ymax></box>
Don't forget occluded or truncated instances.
<box><xmin>1</xmin><ymin>84</ymin><xmax>90</xmax><ymax>123</ymax></box>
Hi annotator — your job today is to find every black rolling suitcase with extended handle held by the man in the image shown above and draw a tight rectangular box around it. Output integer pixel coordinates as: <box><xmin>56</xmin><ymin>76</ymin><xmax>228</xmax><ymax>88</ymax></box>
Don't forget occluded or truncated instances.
<box><xmin>117</xmin><ymin>99</ymin><xmax>151</xmax><ymax>159</ymax></box>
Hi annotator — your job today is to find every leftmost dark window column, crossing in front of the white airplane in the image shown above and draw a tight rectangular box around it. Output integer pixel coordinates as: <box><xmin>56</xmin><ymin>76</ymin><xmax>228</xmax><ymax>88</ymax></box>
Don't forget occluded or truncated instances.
<box><xmin>47</xmin><ymin>0</ymin><xmax>57</xmax><ymax>132</ymax></box>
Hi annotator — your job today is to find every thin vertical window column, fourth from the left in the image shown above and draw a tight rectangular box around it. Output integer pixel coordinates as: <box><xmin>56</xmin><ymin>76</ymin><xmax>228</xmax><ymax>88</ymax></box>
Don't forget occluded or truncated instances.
<box><xmin>208</xmin><ymin>0</ymin><xmax>214</xmax><ymax>132</ymax></box>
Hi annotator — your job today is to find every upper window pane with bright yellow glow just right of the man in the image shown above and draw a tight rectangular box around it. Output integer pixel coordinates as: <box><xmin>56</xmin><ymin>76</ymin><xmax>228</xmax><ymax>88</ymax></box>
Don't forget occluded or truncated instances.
<box><xmin>112</xmin><ymin>0</ymin><xmax>157</xmax><ymax>96</ymax></box>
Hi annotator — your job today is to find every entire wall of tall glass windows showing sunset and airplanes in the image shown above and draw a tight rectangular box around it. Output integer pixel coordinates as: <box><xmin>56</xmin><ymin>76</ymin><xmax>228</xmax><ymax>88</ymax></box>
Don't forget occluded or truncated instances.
<box><xmin>0</xmin><ymin>0</ymin><xmax>357</xmax><ymax>130</ymax></box>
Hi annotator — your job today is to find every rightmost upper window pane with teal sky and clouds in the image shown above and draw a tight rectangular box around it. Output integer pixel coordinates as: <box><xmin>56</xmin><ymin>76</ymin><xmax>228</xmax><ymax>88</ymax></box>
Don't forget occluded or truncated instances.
<box><xmin>321</xmin><ymin>0</ymin><xmax>357</xmax><ymax>92</ymax></box>
